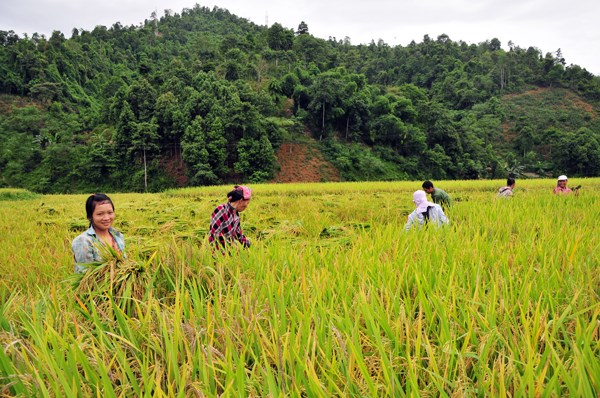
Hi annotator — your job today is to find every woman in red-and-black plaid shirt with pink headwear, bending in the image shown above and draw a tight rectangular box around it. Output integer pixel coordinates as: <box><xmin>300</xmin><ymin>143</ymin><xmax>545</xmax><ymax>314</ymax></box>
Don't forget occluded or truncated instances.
<box><xmin>208</xmin><ymin>185</ymin><xmax>252</xmax><ymax>254</ymax></box>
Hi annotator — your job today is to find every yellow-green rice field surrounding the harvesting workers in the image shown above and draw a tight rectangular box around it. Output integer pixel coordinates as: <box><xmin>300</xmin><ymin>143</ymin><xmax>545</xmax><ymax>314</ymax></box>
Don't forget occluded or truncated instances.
<box><xmin>0</xmin><ymin>178</ymin><xmax>600</xmax><ymax>397</ymax></box>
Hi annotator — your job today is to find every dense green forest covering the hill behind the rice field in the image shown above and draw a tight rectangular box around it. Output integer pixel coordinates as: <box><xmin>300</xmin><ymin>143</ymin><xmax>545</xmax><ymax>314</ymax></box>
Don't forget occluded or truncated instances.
<box><xmin>0</xmin><ymin>5</ymin><xmax>600</xmax><ymax>193</ymax></box>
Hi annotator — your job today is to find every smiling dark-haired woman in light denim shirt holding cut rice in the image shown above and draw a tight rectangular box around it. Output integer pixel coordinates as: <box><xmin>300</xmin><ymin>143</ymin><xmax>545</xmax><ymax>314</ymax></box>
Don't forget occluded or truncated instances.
<box><xmin>71</xmin><ymin>193</ymin><xmax>125</xmax><ymax>273</ymax></box>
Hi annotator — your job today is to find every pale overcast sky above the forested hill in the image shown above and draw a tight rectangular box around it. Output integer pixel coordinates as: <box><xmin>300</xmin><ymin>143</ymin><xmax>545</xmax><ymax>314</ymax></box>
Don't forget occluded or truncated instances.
<box><xmin>0</xmin><ymin>0</ymin><xmax>600</xmax><ymax>76</ymax></box>
